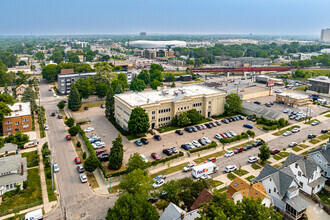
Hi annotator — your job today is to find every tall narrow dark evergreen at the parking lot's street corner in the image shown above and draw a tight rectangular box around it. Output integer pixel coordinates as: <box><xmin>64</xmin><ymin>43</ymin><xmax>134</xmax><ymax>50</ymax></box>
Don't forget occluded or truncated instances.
<box><xmin>108</xmin><ymin>133</ymin><xmax>124</xmax><ymax>170</ymax></box>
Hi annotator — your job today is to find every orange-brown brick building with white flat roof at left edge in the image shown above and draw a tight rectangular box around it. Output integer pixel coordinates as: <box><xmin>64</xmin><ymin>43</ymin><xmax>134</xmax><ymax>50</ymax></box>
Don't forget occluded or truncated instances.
<box><xmin>2</xmin><ymin>102</ymin><xmax>32</xmax><ymax>136</ymax></box>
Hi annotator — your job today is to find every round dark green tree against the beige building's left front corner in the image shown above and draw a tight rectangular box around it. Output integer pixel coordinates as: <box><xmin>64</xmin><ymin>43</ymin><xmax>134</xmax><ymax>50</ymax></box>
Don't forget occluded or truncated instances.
<box><xmin>128</xmin><ymin>107</ymin><xmax>150</xmax><ymax>134</ymax></box>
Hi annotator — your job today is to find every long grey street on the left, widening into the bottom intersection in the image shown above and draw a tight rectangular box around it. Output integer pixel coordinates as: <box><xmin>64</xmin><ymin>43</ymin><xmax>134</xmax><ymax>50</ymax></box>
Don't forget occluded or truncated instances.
<box><xmin>40</xmin><ymin>81</ymin><xmax>116</xmax><ymax>219</ymax></box>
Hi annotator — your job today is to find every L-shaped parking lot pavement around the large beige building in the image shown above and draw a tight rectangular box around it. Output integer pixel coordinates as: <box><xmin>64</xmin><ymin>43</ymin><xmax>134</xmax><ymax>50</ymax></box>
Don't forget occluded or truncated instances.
<box><xmin>74</xmin><ymin>107</ymin><xmax>264</xmax><ymax>162</ymax></box>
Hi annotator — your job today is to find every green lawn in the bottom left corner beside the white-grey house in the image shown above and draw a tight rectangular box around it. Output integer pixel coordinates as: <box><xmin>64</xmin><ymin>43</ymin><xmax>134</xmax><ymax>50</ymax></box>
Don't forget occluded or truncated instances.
<box><xmin>0</xmin><ymin>168</ymin><xmax>42</xmax><ymax>216</ymax></box>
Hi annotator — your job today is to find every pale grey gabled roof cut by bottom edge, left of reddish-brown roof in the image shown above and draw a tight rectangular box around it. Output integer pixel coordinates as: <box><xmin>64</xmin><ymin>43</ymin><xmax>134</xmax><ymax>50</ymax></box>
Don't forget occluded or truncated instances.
<box><xmin>159</xmin><ymin>202</ymin><xmax>201</xmax><ymax>220</ymax></box>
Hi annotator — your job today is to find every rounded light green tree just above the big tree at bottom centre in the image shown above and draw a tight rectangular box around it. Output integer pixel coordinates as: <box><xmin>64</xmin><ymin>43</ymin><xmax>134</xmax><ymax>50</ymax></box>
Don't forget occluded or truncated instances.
<box><xmin>119</xmin><ymin>169</ymin><xmax>151</xmax><ymax>196</ymax></box>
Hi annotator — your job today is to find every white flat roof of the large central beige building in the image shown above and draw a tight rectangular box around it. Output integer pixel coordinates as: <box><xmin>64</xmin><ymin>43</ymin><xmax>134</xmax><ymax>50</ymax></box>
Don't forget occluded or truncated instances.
<box><xmin>115</xmin><ymin>85</ymin><xmax>224</xmax><ymax>106</ymax></box>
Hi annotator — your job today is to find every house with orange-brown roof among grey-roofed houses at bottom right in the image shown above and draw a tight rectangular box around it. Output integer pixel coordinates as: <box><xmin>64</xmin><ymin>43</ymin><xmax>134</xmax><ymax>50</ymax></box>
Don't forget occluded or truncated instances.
<box><xmin>227</xmin><ymin>177</ymin><xmax>273</xmax><ymax>207</ymax></box>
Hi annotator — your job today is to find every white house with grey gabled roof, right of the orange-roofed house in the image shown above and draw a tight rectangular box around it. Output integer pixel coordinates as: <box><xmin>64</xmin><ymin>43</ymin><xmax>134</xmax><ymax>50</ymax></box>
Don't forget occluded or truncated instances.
<box><xmin>252</xmin><ymin>164</ymin><xmax>309</xmax><ymax>219</ymax></box>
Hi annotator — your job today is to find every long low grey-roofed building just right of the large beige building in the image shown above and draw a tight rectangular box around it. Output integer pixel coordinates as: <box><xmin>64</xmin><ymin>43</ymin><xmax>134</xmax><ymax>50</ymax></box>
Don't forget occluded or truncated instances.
<box><xmin>242</xmin><ymin>102</ymin><xmax>289</xmax><ymax>121</ymax></box>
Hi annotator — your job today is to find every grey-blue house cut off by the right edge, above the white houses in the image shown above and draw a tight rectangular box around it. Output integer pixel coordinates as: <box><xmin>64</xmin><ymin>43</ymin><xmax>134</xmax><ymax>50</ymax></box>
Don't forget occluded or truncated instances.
<box><xmin>308</xmin><ymin>141</ymin><xmax>330</xmax><ymax>180</ymax></box>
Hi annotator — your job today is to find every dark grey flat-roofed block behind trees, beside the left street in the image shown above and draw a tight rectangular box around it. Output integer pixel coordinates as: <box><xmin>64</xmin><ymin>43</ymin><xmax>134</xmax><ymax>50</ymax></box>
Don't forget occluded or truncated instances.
<box><xmin>57</xmin><ymin>71</ymin><xmax>96</xmax><ymax>95</ymax></box>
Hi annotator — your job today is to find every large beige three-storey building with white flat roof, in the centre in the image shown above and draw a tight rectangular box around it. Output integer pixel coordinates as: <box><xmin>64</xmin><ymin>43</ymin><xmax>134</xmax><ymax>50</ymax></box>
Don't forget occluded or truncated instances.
<box><xmin>115</xmin><ymin>85</ymin><xmax>226</xmax><ymax>130</ymax></box>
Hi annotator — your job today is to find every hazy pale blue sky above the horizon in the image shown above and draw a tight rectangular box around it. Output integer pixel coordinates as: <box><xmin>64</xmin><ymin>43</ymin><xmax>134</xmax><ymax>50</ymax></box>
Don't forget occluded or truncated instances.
<box><xmin>0</xmin><ymin>0</ymin><xmax>330</xmax><ymax>35</ymax></box>
